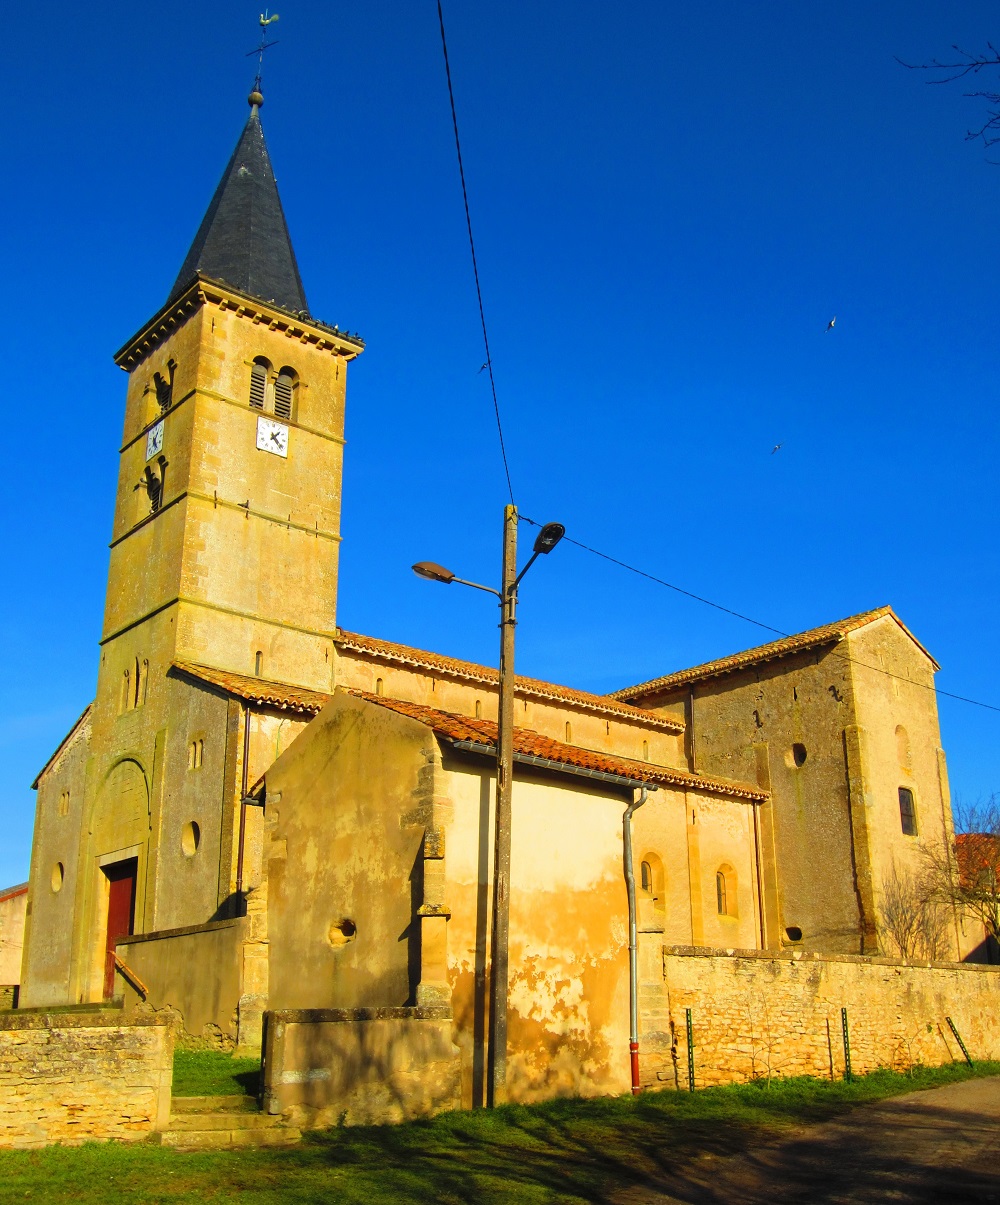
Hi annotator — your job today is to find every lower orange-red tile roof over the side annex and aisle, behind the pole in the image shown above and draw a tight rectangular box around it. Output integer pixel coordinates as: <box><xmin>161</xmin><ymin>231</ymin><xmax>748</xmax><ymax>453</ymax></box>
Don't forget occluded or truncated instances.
<box><xmin>348</xmin><ymin>690</ymin><xmax>770</xmax><ymax>803</ymax></box>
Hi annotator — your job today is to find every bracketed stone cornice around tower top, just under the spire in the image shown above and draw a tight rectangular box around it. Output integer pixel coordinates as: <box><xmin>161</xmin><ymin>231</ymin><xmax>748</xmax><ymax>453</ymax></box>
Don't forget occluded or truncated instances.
<box><xmin>114</xmin><ymin>276</ymin><xmax>365</xmax><ymax>372</ymax></box>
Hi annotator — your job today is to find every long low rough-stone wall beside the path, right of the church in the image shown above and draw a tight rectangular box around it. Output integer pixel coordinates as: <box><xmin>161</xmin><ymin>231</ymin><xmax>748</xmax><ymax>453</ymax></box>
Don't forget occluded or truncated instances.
<box><xmin>640</xmin><ymin>946</ymin><xmax>1000</xmax><ymax>1088</ymax></box>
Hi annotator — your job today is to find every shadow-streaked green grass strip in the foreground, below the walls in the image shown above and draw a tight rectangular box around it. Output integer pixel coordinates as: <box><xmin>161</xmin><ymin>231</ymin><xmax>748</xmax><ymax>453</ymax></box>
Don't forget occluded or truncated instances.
<box><xmin>0</xmin><ymin>1063</ymin><xmax>1000</xmax><ymax>1205</ymax></box>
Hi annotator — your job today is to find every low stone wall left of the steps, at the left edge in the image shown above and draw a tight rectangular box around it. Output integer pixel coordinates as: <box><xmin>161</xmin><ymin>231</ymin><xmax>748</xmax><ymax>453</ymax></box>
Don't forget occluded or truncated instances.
<box><xmin>0</xmin><ymin>1010</ymin><xmax>173</xmax><ymax>1148</ymax></box>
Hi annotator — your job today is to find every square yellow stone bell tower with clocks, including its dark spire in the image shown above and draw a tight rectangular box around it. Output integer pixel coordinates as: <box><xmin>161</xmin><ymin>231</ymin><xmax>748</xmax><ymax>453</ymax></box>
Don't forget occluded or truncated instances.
<box><xmin>98</xmin><ymin>90</ymin><xmax>364</xmax><ymax>706</ymax></box>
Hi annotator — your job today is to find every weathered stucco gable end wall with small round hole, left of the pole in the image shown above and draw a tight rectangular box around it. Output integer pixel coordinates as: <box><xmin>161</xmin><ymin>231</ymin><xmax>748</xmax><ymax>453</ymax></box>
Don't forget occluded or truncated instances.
<box><xmin>264</xmin><ymin>694</ymin><xmax>436</xmax><ymax>1009</ymax></box>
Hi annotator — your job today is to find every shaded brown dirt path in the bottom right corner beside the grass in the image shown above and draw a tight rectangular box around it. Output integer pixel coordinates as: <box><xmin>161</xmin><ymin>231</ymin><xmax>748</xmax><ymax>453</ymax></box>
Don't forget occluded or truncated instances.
<box><xmin>617</xmin><ymin>1078</ymin><xmax>1000</xmax><ymax>1205</ymax></box>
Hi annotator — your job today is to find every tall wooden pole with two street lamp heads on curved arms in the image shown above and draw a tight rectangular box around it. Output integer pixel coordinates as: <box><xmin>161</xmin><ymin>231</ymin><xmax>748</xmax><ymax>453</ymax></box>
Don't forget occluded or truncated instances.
<box><xmin>413</xmin><ymin>505</ymin><xmax>566</xmax><ymax>1105</ymax></box>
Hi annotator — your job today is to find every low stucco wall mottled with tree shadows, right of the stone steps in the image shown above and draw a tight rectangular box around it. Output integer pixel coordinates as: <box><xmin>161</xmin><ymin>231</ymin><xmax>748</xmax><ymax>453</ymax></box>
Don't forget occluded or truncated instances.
<box><xmin>263</xmin><ymin>1005</ymin><xmax>461</xmax><ymax>1128</ymax></box>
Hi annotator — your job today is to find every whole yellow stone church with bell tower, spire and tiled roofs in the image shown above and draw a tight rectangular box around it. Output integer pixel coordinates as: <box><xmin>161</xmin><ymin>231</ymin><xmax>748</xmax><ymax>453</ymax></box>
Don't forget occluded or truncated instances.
<box><xmin>20</xmin><ymin>93</ymin><xmax>992</xmax><ymax>1117</ymax></box>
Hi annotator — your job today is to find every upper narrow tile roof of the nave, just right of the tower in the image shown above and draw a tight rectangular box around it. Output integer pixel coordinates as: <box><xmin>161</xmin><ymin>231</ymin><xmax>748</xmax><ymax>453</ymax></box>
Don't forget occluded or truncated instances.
<box><xmin>334</xmin><ymin>629</ymin><xmax>684</xmax><ymax>733</ymax></box>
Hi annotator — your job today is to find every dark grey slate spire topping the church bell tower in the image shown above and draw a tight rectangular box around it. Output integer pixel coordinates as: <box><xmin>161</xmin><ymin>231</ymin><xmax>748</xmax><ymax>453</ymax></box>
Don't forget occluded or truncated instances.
<box><xmin>167</xmin><ymin>89</ymin><xmax>308</xmax><ymax>312</ymax></box>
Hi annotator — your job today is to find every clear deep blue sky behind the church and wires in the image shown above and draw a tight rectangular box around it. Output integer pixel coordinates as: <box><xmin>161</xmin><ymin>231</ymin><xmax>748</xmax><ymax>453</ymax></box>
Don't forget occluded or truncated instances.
<box><xmin>0</xmin><ymin>0</ymin><xmax>1000</xmax><ymax>884</ymax></box>
